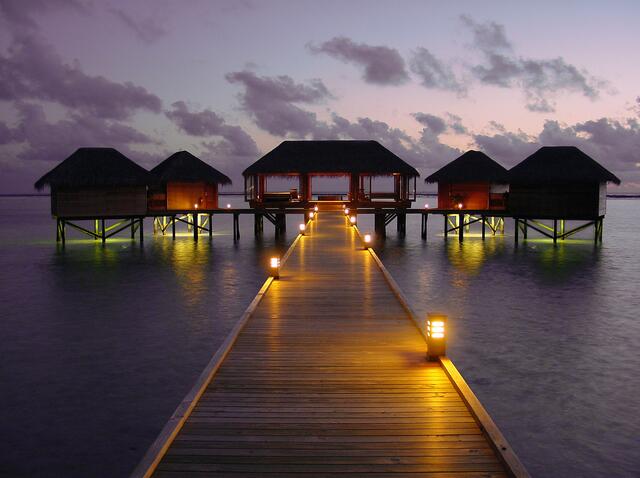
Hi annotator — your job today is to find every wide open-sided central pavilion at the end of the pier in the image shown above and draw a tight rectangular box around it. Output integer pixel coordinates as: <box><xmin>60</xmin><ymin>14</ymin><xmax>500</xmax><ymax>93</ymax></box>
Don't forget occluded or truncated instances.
<box><xmin>243</xmin><ymin>140</ymin><xmax>419</xmax><ymax>208</ymax></box>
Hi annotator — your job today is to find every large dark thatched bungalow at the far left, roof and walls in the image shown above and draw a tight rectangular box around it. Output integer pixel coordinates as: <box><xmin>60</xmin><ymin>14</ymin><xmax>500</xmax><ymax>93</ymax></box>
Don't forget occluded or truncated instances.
<box><xmin>34</xmin><ymin>148</ymin><xmax>149</xmax><ymax>219</ymax></box>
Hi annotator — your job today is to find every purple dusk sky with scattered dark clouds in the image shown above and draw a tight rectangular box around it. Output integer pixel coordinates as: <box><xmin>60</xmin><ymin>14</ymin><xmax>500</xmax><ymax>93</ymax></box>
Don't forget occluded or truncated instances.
<box><xmin>0</xmin><ymin>0</ymin><xmax>640</xmax><ymax>193</ymax></box>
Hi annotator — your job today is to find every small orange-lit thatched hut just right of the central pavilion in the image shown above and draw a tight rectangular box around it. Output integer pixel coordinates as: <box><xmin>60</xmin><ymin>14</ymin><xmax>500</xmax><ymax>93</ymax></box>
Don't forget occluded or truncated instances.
<box><xmin>425</xmin><ymin>151</ymin><xmax>509</xmax><ymax>211</ymax></box>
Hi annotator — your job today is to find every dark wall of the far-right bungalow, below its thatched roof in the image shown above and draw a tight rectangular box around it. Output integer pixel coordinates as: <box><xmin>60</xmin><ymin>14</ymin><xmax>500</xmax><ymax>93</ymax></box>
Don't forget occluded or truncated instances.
<box><xmin>508</xmin><ymin>183</ymin><xmax>607</xmax><ymax>219</ymax></box>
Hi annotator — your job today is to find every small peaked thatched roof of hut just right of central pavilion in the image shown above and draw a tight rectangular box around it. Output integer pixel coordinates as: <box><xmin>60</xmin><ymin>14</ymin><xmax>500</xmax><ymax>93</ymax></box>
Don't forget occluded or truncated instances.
<box><xmin>425</xmin><ymin>150</ymin><xmax>509</xmax><ymax>184</ymax></box>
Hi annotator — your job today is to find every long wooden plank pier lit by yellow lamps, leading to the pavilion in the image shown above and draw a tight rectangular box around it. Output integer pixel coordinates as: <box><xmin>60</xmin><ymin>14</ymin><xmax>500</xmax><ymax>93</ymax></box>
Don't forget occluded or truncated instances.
<box><xmin>131</xmin><ymin>210</ymin><xmax>528</xmax><ymax>478</ymax></box>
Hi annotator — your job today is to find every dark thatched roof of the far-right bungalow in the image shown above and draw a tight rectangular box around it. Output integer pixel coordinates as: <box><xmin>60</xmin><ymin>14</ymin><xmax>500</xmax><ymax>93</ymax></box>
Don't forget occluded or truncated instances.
<box><xmin>509</xmin><ymin>146</ymin><xmax>620</xmax><ymax>184</ymax></box>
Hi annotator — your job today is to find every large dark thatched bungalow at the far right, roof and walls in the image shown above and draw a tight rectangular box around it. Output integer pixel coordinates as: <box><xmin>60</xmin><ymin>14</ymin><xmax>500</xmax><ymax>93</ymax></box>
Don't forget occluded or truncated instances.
<box><xmin>509</xmin><ymin>146</ymin><xmax>620</xmax><ymax>219</ymax></box>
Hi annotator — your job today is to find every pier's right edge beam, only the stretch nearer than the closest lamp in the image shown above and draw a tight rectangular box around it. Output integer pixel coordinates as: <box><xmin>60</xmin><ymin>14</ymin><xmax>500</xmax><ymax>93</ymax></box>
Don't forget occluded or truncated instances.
<box><xmin>440</xmin><ymin>357</ymin><xmax>530</xmax><ymax>478</ymax></box>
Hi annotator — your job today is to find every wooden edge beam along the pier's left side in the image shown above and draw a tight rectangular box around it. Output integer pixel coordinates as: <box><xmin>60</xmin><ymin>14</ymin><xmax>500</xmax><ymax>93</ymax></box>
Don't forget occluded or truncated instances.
<box><xmin>130</xmin><ymin>230</ymin><xmax>301</xmax><ymax>478</ymax></box>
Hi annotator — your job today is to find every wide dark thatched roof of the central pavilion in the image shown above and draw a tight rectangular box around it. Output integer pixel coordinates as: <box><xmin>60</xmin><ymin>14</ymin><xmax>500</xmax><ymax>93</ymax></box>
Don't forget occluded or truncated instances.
<box><xmin>242</xmin><ymin>140</ymin><xmax>420</xmax><ymax>176</ymax></box>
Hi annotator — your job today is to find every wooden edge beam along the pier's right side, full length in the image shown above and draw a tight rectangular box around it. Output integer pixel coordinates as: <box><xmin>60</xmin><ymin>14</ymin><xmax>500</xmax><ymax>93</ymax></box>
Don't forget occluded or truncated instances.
<box><xmin>354</xmin><ymin>226</ymin><xmax>530</xmax><ymax>478</ymax></box>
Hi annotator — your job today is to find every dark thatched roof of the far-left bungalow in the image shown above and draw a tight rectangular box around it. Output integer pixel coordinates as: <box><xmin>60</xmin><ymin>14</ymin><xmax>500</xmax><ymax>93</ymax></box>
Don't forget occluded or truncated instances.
<box><xmin>34</xmin><ymin>148</ymin><xmax>149</xmax><ymax>189</ymax></box>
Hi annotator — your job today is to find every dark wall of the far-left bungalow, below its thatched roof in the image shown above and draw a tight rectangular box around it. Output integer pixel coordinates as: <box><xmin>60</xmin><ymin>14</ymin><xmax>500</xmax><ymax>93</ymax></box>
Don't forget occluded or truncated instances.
<box><xmin>51</xmin><ymin>186</ymin><xmax>147</xmax><ymax>218</ymax></box>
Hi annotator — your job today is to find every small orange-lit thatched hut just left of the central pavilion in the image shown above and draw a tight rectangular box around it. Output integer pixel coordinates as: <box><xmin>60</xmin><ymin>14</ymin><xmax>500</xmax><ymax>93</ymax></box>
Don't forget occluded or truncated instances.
<box><xmin>149</xmin><ymin>151</ymin><xmax>231</xmax><ymax>212</ymax></box>
